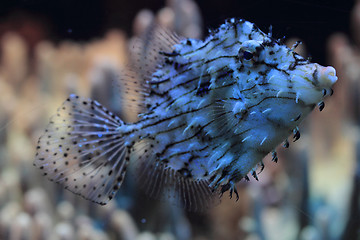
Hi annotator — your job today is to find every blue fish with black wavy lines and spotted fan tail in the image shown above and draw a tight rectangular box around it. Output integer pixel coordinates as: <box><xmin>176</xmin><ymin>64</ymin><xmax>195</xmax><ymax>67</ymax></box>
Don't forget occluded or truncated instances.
<box><xmin>34</xmin><ymin>19</ymin><xmax>337</xmax><ymax>210</ymax></box>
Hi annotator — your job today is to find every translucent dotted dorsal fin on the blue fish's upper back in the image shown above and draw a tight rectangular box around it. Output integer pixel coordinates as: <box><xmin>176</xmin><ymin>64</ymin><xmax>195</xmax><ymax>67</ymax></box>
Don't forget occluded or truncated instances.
<box><xmin>118</xmin><ymin>24</ymin><xmax>180</xmax><ymax>121</ymax></box>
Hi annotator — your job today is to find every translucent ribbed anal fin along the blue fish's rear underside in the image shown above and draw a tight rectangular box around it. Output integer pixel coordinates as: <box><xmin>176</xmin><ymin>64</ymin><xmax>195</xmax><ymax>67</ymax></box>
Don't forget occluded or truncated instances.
<box><xmin>132</xmin><ymin>140</ymin><xmax>220</xmax><ymax>211</ymax></box>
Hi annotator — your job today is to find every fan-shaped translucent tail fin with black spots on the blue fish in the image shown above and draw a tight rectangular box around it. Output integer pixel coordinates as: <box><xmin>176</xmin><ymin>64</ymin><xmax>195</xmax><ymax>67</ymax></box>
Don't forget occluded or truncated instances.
<box><xmin>34</xmin><ymin>94</ymin><xmax>130</xmax><ymax>205</ymax></box>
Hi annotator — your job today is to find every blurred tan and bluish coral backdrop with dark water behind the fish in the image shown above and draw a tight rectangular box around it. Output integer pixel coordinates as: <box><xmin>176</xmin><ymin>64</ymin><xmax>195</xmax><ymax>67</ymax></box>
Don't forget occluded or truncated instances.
<box><xmin>0</xmin><ymin>0</ymin><xmax>360</xmax><ymax>240</ymax></box>
